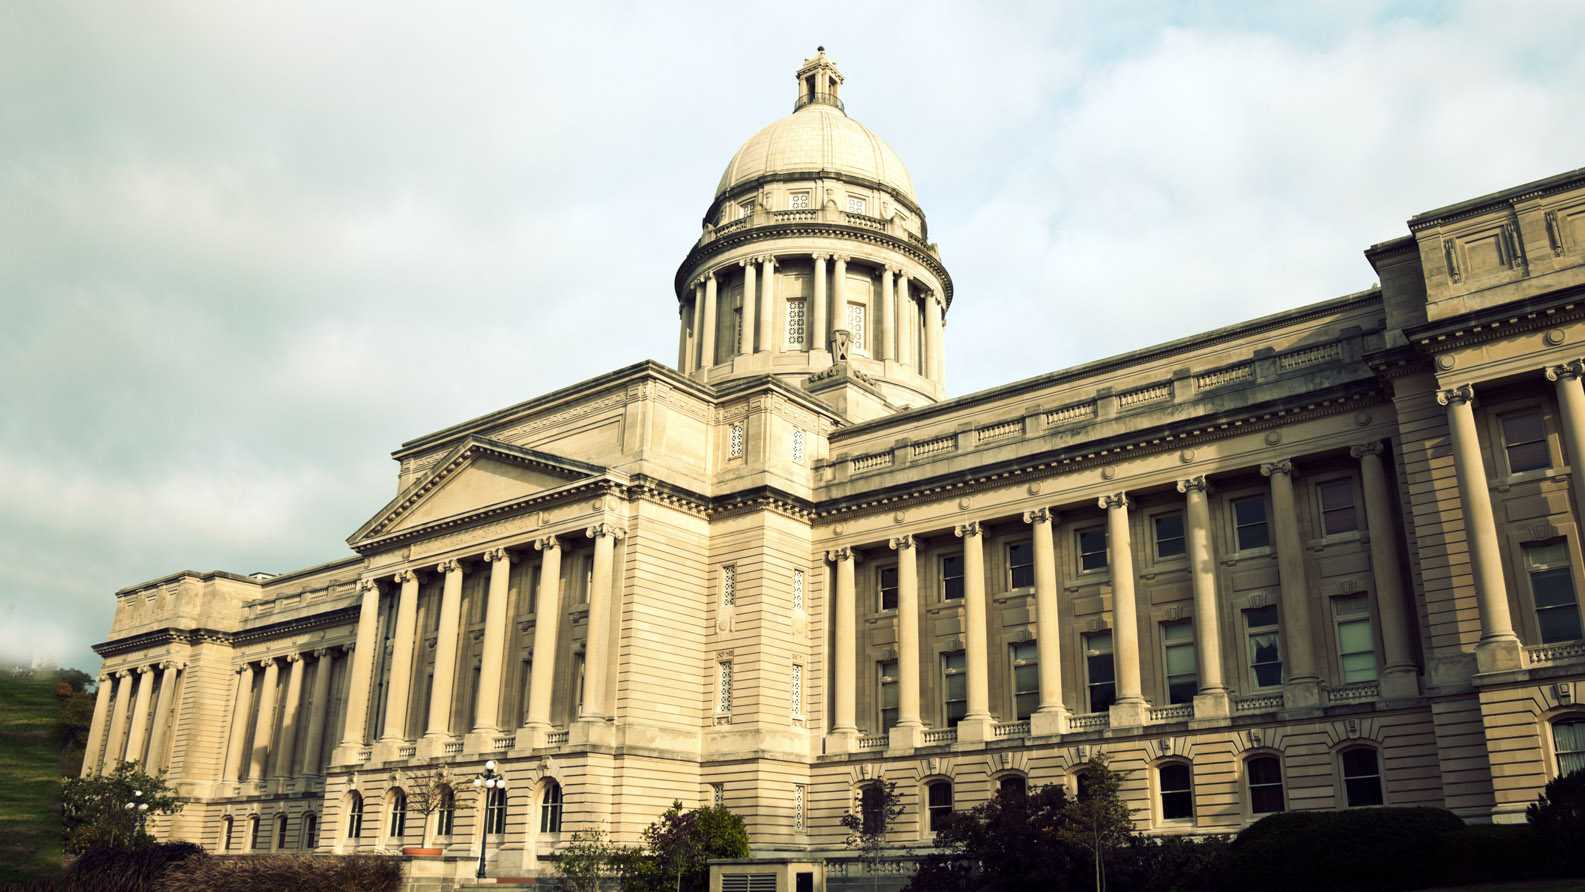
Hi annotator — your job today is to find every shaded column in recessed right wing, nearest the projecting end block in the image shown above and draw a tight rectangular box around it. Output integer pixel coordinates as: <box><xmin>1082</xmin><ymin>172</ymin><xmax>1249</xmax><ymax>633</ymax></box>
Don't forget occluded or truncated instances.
<box><xmin>1349</xmin><ymin>440</ymin><xmax>1420</xmax><ymax>700</ymax></box>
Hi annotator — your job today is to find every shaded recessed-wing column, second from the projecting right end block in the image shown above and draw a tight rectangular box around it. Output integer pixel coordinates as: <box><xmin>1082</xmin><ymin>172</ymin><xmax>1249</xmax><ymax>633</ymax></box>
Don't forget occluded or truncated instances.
<box><xmin>1260</xmin><ymin>459</ymin><xmax>1320</xmax><ymax>710</ymax></box>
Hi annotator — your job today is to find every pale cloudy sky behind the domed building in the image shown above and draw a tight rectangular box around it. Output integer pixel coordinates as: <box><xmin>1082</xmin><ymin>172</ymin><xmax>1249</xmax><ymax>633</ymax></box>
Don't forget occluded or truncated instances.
<box><xmin>0</xmin><ymin>2</ymin><xmax>1585</xmax><ymax>669</ymax></box>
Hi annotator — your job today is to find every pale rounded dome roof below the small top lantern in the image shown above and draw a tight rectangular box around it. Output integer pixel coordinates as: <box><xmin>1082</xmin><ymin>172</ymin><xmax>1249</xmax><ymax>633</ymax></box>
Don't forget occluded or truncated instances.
<box><xmin>715</xmin><ymin>103</ymin><xmax>919</xmax><ymax>204</ymax></box>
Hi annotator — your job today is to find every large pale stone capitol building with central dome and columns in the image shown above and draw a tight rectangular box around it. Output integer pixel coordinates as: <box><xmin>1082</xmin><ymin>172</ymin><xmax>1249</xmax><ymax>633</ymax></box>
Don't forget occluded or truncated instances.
<box><xmin>84</xmin><ymin>51</ymin><xmax>1585</xmax><ymax>892</ymax></box>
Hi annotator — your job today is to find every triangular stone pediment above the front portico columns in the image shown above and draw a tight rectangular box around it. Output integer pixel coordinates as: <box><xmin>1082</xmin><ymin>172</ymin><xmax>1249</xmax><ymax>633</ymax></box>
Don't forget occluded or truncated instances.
<box><xmin>347</xmin><ymin>437</ymin><xmax>605</xmax><ymax>547</ymax></box>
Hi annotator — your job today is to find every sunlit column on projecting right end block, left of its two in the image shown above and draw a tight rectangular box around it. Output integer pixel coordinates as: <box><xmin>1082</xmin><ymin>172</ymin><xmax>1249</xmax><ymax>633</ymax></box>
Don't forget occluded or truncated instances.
<box><xmin>1436</xmin><ymin>383</ymin><xmax>1521</xmax><ymax>672</ymax></box>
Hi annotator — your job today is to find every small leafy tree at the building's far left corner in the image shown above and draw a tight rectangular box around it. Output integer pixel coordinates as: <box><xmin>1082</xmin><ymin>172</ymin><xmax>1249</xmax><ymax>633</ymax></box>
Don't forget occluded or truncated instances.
<box><xmin>60</xmin><ymin>762</ymin><xmax>182</xmax><ymax>854</ymax></box>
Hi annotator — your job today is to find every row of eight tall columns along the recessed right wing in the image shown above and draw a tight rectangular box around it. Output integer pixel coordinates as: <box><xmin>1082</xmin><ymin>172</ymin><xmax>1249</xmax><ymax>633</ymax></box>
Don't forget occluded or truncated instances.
<box><xmin>826</xmin><ymin>442</ymin><xmax>1417</xmax><ymax>751</ymax></box>
